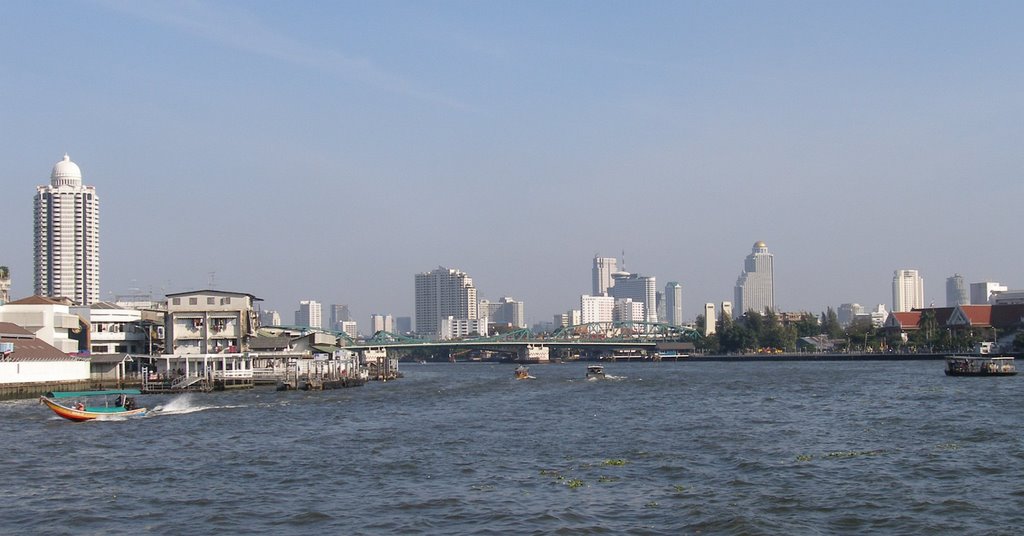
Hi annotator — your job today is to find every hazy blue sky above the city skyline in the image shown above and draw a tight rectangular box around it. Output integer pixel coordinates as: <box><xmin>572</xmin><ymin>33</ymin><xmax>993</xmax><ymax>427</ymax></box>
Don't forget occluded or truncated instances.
<box><xmin>0</xmin><ymin>0</ymin><xmax>1024</xmax><ymax>325</ymax></box>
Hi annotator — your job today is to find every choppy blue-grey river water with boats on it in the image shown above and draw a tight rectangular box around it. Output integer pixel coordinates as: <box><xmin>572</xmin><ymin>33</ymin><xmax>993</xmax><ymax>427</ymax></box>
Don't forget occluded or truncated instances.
<box><xmin>0</xmin><ymin>361</ymin><xmax>1024</xmax><ymax>535</ymax></box>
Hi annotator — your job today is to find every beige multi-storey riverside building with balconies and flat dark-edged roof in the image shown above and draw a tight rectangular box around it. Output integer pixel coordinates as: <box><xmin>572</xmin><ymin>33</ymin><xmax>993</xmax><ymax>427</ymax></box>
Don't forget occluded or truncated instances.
<box><xmin>164</xmin><ymin>290</ymin><xmax>262</xmax><ymax>356</ymax></box>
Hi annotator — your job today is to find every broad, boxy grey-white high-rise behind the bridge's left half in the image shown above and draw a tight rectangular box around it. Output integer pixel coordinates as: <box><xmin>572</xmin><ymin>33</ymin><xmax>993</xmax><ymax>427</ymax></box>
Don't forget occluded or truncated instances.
<box><xmin>416</xmin><ymin>266</ymin><xmax>477</xmax><ymax>336</ymax></box>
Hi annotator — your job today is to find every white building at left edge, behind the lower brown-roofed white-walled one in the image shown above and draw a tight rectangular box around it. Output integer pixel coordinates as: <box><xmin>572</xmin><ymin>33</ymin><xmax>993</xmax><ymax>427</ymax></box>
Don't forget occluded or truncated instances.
<box><xmin>0</xmin><ymin>296</ymin><xmax>83</xmax><ymax>354</ymax></box>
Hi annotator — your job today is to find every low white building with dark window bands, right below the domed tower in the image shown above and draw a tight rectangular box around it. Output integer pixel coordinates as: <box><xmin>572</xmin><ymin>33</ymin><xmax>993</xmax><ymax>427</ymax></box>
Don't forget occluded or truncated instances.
<box><xmin>71</xmin><ymin>301</ymin><xmax>149</xmax><ymax>355</ymax></box>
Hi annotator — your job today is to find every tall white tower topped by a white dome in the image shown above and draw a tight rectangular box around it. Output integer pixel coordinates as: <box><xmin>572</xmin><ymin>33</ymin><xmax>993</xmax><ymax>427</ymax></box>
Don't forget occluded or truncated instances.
<box><xmin>33</xmin><ymin>155</ymin><xmax>99</xmax><ymax>305</ymax></box>
